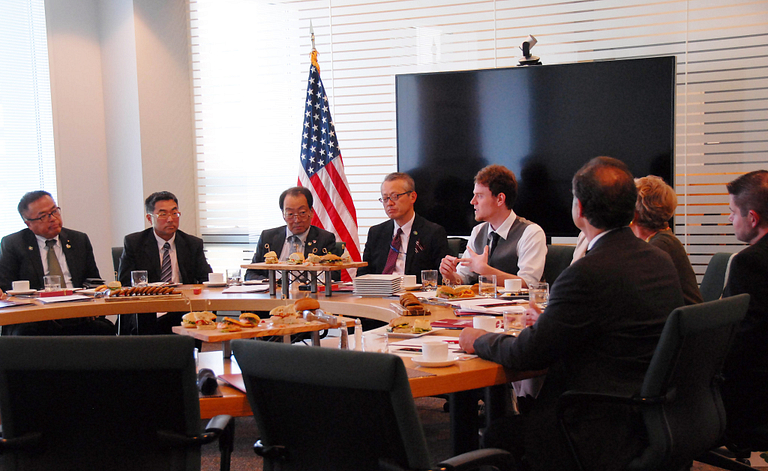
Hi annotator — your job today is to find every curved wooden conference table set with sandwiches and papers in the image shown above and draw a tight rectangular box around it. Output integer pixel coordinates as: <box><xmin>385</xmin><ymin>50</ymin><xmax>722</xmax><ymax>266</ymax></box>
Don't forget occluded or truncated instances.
<box><xmin>0</xmin><ymin>285</ymin><xmax>543</xmax><ymax>454</ymax></box>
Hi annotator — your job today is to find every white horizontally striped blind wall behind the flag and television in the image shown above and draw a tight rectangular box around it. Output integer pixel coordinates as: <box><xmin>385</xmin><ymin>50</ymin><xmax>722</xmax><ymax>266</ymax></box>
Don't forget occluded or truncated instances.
<box><xmin>190</xmin><ymin>0</ymin><xmax>768</xmax><ymax>278</ymax></box>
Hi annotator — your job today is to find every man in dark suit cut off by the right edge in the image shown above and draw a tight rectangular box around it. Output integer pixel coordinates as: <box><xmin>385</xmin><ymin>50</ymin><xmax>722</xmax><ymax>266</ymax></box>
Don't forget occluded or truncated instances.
<box><xmin>721</xmin><ymin>170</ymin><xmax>768</xmax><ymax>444</ymax></box>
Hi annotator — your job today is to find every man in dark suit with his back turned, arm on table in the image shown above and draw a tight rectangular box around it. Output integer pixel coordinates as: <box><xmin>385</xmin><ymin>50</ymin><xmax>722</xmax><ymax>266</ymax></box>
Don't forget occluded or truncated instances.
<box><xmin>459</xmin><ymin>157</ymin><xmax>684</xmax><ymax>470</ymax></box>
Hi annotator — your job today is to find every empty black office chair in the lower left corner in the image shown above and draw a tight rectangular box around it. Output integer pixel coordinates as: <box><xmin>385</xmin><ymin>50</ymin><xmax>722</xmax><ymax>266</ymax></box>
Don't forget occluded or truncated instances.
<box><xmin>0</xmin><ymin>335</ymin><xmax>234</xmax><ymax>471</ymax></box>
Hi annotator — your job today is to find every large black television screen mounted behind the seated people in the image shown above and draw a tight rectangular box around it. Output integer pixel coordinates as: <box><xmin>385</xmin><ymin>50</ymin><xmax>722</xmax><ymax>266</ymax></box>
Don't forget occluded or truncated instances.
<box><xmin>395</xmin><ymin>56</ymin><xmax>675</xmax><ymax>237</ymax></box>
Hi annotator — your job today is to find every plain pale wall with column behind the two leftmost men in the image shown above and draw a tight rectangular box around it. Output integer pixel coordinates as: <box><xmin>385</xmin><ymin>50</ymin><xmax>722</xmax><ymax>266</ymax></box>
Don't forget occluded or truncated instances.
<box><xmin>46</xmin><ymin>0</ymin><xmax>198</xmax><ymax>279</ymax></box>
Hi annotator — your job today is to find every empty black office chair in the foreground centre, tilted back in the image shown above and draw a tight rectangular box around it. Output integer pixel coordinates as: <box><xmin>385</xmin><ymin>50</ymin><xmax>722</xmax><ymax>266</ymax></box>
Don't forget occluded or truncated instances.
<box><xmin>232</xmin><ymin>340</ymin><xmax>511</xmax><ymax>471</ymax></box>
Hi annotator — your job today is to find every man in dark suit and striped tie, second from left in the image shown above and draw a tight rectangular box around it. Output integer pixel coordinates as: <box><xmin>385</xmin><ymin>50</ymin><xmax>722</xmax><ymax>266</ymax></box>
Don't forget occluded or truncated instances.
<box><xmin>118</xmin><ymin>191</ymin><xmax>212</xmax><ymax>334</ymax></box>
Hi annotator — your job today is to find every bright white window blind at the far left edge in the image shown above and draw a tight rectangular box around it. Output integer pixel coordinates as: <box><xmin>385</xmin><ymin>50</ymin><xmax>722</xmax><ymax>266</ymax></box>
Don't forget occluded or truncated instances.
<box><xmin>0</xmin><ymin>0</ymin><xmax>56</xmax><ymax>234</ymax></box>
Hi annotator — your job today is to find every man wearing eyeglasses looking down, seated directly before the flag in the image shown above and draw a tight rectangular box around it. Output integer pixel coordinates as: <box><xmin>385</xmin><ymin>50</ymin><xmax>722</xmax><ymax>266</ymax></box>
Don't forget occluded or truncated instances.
<box><xmin>245</xmin><ymin>186</ymin><xmax>332</xmax><ymax>280</ymax></box>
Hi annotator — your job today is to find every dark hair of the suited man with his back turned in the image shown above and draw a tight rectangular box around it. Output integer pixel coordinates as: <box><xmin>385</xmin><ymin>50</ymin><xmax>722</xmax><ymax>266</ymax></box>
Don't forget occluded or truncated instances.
<box><xmin>572</xmin><ymin>157</ymin><xmax>637</xmax><ymax>230</ymax></box>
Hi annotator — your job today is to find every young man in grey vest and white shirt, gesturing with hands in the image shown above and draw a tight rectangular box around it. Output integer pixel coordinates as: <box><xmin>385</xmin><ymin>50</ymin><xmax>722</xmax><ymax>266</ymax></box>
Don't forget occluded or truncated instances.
<box><xmin>440</xmin><ymin>165</ymin><xmax>547</xmax><ymax>287</ymax></box>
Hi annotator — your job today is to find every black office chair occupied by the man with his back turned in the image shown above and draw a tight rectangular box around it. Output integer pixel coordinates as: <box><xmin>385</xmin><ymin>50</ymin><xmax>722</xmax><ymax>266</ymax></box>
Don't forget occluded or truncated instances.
<box><xmin>557</xmin><ymin>294</ymin><xmax>749</xmax><ymax>471</ymax></box>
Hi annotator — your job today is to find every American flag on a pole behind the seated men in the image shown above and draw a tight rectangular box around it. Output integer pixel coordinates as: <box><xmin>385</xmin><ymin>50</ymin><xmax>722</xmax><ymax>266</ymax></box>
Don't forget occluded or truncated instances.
<box><xmin>299</xmin><ymin>51</ymin><xmax>360</xmax><ymax>280</ymax></box>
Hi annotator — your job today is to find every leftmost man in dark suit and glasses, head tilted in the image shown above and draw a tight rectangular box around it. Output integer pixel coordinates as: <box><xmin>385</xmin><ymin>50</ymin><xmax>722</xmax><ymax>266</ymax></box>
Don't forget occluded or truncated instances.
<box><xmin>0</xmin><ymin>191</ymin><xmax>115</xmax><ymax>335</ymax></box>
